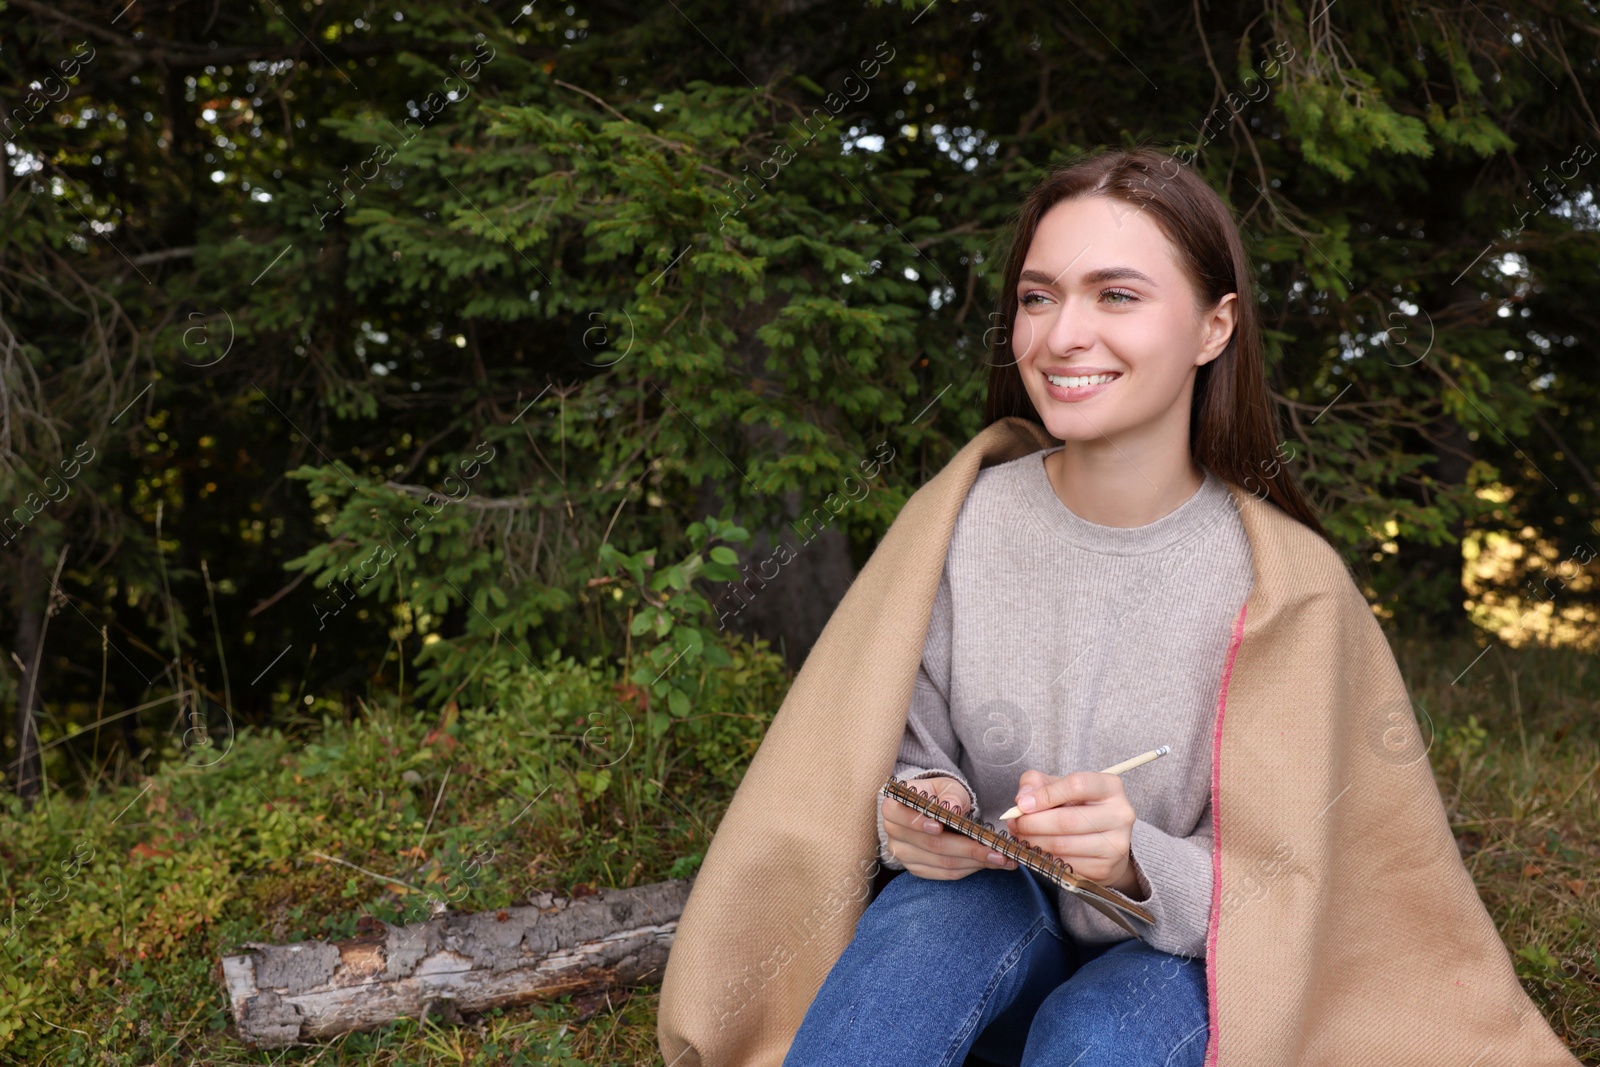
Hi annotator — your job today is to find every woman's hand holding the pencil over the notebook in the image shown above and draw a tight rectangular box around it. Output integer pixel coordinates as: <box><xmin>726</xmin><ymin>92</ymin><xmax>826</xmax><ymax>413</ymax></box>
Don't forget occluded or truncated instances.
<box><xmin>1008</xmin><ymin>771</ymin><xmax>1139</xmax><ymax>896</ymax></box>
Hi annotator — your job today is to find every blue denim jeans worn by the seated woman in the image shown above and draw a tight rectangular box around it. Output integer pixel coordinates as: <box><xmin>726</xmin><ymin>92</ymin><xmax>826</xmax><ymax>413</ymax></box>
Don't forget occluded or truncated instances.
<box><xmin>784</xmin><ymin>867</ymin><xmax>1210</xmax><ymax>1067</ymax></box>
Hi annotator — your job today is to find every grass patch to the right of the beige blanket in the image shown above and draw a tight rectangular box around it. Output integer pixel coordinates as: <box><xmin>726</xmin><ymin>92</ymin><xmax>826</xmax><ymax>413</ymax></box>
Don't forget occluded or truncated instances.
<box><xmin>1395</xmin><ymin>640</ymin><xmax>1600</xmax><ymax>1064</ymax></box>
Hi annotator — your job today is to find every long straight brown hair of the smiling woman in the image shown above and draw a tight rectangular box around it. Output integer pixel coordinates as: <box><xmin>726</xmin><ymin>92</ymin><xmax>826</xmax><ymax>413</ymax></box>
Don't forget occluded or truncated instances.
<box><xmin>984</xmin><ymin>147</ymin><xmax>1328</xmax><ymax>539</ymax></box>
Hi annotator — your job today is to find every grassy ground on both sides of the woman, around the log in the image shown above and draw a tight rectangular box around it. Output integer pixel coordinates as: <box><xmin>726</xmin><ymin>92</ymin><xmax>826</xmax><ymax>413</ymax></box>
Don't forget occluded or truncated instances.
<box><xmin>0</xmin><ymin>640</ymin><xmax>1600</xmax><ymax>1067</ymax></box>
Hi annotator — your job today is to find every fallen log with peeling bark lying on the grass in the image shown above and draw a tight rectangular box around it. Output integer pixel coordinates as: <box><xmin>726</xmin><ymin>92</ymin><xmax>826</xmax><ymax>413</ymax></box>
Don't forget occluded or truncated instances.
<box><xmin>221</xmin><ymin>880</ymin><xmax>691</xmax><ymax>1048</ymax></box>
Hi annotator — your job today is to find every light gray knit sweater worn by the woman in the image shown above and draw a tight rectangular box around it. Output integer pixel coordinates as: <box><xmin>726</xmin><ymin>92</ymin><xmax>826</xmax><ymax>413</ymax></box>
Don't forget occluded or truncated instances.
<box><xmin>872</xmin><ymin>446</ymin><xmax>1253</xmax><ymax>957</ymax></box>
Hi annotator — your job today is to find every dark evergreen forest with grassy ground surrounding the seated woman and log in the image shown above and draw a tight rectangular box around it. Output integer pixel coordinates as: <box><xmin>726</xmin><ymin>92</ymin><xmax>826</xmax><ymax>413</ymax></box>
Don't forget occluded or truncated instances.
<box><xmin>0</xmin><ymin>0</ymin><xmax>1600</xmax><ymax>1062</ymax></box>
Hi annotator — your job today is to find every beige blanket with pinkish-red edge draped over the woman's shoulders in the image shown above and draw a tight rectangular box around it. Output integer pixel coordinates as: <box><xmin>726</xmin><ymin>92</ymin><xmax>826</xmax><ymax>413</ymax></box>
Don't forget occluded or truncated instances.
<box><xmin>658</xmin><ymin>418</ymin><xmax>1578</xmax><ymax>1067</ymax></box>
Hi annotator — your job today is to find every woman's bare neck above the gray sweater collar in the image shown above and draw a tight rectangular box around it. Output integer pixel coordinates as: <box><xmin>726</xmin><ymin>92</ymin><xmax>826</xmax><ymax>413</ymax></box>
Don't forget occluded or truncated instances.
<box><xmin>1045</xmin><ymin>438</ymin><xmax>1205</xmax><ymax>526</ymax></box>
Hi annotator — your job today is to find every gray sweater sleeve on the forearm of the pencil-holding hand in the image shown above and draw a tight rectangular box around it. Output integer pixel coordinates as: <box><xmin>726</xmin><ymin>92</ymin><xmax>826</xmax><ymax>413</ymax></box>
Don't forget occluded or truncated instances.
<box><xmin>1062</xmin><ymin>801</ymin><xmax>1211</xmax><ymax>958</ymax></box>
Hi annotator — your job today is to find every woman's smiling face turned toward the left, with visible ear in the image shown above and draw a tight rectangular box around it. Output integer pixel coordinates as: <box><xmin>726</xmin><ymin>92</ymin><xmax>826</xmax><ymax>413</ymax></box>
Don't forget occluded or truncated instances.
<box><xmin>1011</xmin><ymin>197</ymin><xmax>1237</xmax><ymax>454</ymax></box>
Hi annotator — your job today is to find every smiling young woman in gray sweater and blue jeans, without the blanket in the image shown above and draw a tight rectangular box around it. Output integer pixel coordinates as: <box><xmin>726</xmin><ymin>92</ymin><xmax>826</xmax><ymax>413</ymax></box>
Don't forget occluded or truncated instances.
<box><xmin>784</xmin><ymin>149</ymin><xmax>1322</xmax><ymax>1067</ymax></box>
